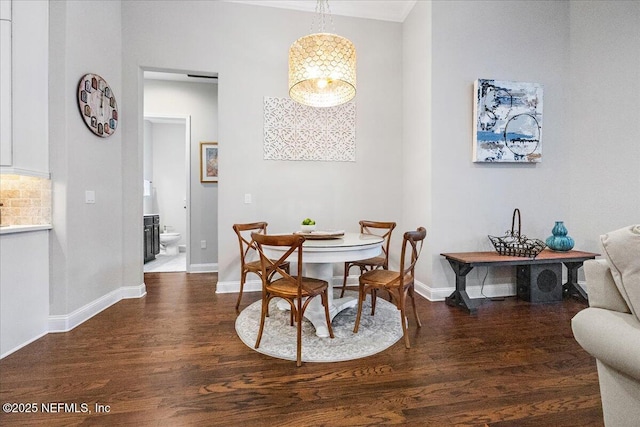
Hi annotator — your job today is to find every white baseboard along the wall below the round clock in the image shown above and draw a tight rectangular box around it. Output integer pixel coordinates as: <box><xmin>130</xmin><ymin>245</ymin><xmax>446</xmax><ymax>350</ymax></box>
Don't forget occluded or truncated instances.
<box><xmin>49</xmin><ymin>283</ymin><xmax>147</xmax><ymax>333</ymax></box>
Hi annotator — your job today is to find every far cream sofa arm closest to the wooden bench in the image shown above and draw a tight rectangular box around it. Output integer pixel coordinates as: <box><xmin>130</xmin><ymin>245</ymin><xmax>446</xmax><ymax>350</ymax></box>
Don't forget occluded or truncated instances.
<box><xmin>583</xmin><ymin>259</ymin><xmax>631</xmax><ymax>313</ymax></box>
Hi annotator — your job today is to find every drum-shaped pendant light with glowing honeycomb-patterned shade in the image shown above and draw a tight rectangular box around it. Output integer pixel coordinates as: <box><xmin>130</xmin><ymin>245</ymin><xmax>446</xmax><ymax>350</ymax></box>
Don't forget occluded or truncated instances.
<box><xmin>289</xmin><ymin>0</ymin><xmax>356</xmax><ymax>107</ymax></box>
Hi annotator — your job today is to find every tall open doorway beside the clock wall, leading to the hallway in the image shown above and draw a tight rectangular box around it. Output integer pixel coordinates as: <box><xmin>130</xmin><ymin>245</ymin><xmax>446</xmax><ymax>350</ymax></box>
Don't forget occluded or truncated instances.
<box><xmin>143</xmin><ymin>70</ymin><xmax>218</xmax><ymax>273</ymax></box>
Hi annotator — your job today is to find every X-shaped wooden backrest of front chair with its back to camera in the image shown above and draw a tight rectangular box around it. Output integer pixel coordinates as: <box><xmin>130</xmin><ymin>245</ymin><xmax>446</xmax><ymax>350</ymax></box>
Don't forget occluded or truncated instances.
<box><xmin>251</xmin><ymin>233</ymin><xmax>305</xmax><ymax>297</ymax></box>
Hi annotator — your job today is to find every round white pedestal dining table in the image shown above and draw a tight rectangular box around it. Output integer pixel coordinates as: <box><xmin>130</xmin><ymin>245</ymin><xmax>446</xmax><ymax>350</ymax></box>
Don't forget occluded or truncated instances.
<box><xmin>264</xmin><ymin>233</ymin><xmax>384</xmax><ymax>338</ymax></box>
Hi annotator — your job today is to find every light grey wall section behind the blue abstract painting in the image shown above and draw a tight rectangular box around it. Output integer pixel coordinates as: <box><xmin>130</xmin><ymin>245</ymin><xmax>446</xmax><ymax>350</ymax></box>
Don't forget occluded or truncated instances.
<box><xmin>418</xmin><ymin>1</ymin><xmax>572</xmax><ymax>298</ymax></box>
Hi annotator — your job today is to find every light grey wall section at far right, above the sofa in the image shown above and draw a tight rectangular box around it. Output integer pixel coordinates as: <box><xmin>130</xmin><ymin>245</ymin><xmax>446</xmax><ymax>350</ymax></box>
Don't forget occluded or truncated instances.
<box><xmin>566</xmin><ymin>1</ymin><xmax>640</xmax><ymax>252</ymax></box>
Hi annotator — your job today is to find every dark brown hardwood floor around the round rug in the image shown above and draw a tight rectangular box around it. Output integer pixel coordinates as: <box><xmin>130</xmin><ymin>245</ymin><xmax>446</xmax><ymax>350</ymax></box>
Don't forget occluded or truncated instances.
<box><xmin>0</xmin><ymin>273</ymin><xmax>603</xmax><ymax>427</ymax></box>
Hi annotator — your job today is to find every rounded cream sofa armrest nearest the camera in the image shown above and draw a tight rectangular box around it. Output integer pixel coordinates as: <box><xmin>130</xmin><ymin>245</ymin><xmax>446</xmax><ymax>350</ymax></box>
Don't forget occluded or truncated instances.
<box><xmin>571</xmin><ymin>307</ymin><xmax>640</xmax><ymax>381</ymax></box>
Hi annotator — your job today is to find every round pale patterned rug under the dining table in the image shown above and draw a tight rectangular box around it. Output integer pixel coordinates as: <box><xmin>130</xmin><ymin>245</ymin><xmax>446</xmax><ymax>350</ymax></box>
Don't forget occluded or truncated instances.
<box><xmin>236</xmin><ymin>292</ymin><xmax>402</xmax><ymax>362</ymax></box>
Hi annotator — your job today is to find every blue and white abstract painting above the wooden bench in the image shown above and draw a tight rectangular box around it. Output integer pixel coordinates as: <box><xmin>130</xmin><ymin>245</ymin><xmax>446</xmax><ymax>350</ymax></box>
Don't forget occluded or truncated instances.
<box><xmin>473</xmin><ymin>79</ymin><xmax>542</xmax><ymax>163</ymax></box>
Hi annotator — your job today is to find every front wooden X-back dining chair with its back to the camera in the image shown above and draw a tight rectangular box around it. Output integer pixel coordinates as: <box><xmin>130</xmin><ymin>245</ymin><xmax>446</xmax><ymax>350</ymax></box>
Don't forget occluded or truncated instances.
<box><xmin>251</xmin><ymin>233</ymin><xmax>333</xmax><ymax>366</ymax></box>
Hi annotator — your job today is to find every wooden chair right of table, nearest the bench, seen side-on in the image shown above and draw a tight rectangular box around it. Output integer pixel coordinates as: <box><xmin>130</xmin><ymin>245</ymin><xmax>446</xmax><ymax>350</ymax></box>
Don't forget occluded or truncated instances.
<box><xmin>353</xmin><ymin>227</ymin><xmax>427</xmax><ymax>348</ymax></box>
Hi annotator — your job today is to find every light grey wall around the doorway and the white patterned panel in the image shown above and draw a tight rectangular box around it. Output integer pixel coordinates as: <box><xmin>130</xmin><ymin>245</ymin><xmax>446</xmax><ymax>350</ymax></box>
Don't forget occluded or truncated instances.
<box><xmin>122</xmin><ymin>1</ymin><xmax>402</xmax><ymax>288</ymax></box>
